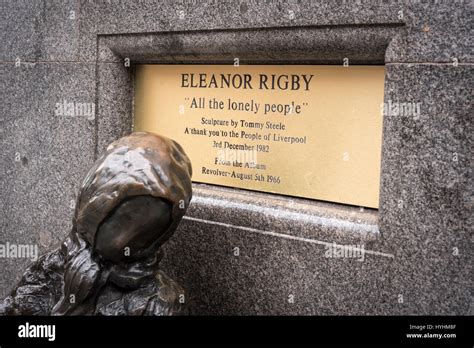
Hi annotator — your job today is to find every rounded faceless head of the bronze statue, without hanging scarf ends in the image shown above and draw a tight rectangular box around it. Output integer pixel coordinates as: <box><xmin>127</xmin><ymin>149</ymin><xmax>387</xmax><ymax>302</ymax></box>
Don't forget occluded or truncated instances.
<box><xmin>74</xmin><ymin>132</ymin><xmax>192</xmax><ymax>262</ymax></box>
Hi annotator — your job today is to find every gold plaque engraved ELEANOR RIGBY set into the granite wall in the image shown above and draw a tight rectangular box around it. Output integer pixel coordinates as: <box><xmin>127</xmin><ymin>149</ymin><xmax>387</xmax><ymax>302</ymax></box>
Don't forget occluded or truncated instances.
<box><xmin>134</xmin><ymin>65</ymin><xmax>385</xmax><ymax>208</ymax></box>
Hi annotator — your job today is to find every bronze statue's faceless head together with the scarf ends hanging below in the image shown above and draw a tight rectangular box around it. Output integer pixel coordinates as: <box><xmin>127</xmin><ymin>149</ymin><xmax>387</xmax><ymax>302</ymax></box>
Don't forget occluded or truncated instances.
<box><xmin>53</xmin><ymin>132</ymin><xmax>192</xmax><ymax>314</ymax></box>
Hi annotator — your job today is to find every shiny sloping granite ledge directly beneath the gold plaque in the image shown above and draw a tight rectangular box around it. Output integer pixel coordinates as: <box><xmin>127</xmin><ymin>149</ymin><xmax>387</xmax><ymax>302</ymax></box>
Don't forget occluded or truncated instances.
<box><xmin>184</xmin><ymin>183</ymin><xmax>380</xmax><ymax>245</ymax></box>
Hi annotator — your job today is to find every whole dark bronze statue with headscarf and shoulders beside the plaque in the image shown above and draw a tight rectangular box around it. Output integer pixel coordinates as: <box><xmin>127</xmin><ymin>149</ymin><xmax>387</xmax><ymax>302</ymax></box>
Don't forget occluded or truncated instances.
<box><xmin>0</xmin><ymin>132</ymin><xmax>192</xmax><ymax>315</ymax></box>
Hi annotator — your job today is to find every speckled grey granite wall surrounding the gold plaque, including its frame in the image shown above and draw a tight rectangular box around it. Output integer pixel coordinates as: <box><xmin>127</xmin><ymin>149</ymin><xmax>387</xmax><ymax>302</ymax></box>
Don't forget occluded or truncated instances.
<box><xmin>0</xmin><ymin>0</ymin><xmax>474</xmax><ymax>315</ymax></box>
